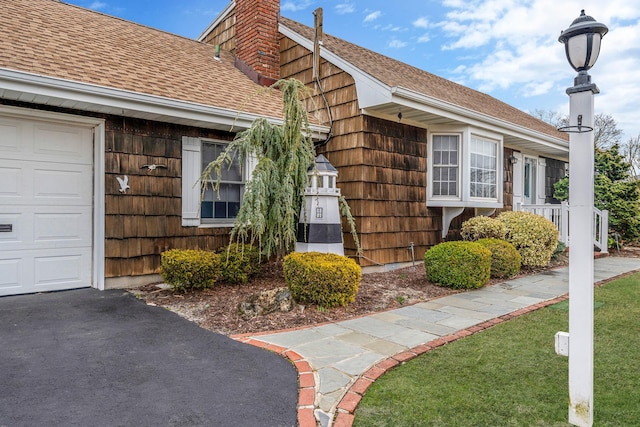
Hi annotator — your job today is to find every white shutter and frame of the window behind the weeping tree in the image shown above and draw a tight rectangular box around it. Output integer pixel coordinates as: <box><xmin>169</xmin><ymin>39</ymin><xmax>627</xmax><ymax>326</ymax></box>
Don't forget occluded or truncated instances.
<box><xmin>182</xmin><ymin>136</ymin><xmax>256</xmax><ymax>228</ymax></box>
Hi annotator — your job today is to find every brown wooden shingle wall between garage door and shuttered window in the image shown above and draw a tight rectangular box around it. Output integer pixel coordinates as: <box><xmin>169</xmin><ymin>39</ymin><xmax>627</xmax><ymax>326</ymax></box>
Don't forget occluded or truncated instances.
<box><xmin>105</xmin><ymin>117</ymin><xmax>234</xmax><ymax>277</ymax></box>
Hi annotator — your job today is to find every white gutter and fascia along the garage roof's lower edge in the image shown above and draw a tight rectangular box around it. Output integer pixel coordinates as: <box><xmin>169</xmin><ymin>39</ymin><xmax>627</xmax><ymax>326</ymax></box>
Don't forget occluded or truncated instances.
<box><xmin>0</xmin><ymin>68</ymin><xmax>312</xmax><ymax>134</ymax></box>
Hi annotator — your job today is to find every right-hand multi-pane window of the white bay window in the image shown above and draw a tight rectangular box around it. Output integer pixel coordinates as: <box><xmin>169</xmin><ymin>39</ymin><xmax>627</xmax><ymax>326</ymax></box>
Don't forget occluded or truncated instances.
<box><xmin>469</xmin><ymin>136</ymin><xmax>498</xmax><ymax>199</ymax></box>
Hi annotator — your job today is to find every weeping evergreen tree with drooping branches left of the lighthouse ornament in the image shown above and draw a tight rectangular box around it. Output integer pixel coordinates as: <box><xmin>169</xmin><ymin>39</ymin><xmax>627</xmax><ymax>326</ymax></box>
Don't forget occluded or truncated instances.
<box><xmin>200</xmin><ymin>79</ymin><xmax>359</xmax><ymax>257</ymax></box>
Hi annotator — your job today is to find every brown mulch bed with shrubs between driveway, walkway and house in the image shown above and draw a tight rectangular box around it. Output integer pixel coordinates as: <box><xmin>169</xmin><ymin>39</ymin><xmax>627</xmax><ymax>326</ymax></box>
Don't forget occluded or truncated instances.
<box><xmin>131</xmin><ymin>248</ymin><xmax>640</xmax><ymax>335</ymax></box>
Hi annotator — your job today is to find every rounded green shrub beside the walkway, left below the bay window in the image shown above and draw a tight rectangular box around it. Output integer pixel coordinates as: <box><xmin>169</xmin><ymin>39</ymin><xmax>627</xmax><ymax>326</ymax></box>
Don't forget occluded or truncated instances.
<box><xmin>424</xmin><ymin>242</ymin><xmax>491</xmax><ymax>289</ymax></box>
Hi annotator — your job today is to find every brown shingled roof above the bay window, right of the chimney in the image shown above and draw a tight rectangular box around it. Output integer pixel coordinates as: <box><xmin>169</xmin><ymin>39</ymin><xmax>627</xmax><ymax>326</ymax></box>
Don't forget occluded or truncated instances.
<box><xmin>280</xmin><ymin>17</ymin><xmax>568</xmax><ymax>149</ymax></box>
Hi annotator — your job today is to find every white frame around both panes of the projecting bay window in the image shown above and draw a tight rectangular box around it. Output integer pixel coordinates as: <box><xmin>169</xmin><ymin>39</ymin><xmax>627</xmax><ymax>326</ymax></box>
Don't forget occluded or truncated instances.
<box><xmin>426</xmin><ymin>126</ymin><xmax>504</xmax><ymax>209</ymax></box>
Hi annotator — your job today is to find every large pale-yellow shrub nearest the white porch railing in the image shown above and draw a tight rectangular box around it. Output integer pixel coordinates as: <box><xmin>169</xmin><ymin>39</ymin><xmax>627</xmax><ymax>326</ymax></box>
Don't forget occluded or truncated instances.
<box><xmin>498</xmin><ymin>211</ymin><xmax>558</xmax><ymax>267</ymax></box>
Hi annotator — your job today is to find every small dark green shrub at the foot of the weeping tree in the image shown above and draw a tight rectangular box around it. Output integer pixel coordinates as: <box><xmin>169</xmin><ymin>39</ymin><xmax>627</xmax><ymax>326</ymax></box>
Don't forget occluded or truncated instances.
<box><xmin>218</xmin><ymin>243</ymin><xmax>262</xmax><ymax>285</ymax></box>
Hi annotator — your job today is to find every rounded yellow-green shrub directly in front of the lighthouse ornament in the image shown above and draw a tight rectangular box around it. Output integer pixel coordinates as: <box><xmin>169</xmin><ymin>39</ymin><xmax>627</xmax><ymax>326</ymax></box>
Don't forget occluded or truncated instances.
<box><xmin>283</xmin><ymin>252</ymin><xmax>362</xmax><ymax>308</ymax></box>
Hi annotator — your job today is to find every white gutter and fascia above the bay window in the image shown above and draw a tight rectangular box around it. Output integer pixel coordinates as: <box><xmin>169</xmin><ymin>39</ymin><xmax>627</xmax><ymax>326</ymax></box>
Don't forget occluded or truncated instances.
<box><xmin>391</xmin><ymin>86</ymin><xmax>569</xmax><ymax>153</ymax></box>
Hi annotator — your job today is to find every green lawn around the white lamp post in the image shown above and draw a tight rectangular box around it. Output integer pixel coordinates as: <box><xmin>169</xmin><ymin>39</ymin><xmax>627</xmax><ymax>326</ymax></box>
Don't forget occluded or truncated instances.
<box><xmin>353</xmin><ymin>274</ymin><xmax>640</xmax><ymax>427</ymax></box>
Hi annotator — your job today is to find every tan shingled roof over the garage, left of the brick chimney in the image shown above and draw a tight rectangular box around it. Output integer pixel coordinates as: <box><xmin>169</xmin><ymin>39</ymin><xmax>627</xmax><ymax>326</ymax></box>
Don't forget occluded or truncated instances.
<box><xmin>0</xmin><ymin>0</ymin><xmax>282</xmax><ymax>127</ymax></box>
